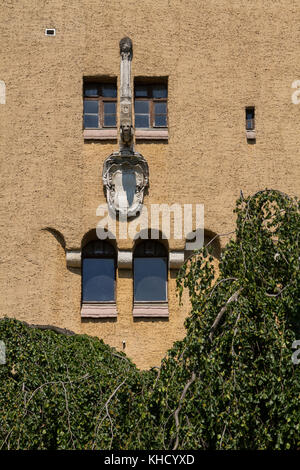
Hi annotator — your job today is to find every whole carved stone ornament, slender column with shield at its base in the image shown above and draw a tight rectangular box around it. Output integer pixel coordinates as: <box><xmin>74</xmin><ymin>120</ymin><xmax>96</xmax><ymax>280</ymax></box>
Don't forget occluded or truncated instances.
<box><xmin>102</xmin><ymin>38</ymin><xmax>149</xmax><ymax>217</ymax></box>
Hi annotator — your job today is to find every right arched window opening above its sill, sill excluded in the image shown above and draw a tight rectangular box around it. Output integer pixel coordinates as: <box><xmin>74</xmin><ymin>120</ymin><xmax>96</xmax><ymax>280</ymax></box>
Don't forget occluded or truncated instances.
<box><xmin>133</xmin><ymin>240</ymin><xmax>168</xmax><ymax>302</ymax></box>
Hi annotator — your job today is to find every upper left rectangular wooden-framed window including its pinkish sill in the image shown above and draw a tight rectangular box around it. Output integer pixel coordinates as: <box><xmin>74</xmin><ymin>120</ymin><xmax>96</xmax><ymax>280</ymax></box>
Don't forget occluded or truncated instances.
<box><xmin>83</xmin><ymin>81</ymin><xmax>117</xmax><ymax>139</ymax></box>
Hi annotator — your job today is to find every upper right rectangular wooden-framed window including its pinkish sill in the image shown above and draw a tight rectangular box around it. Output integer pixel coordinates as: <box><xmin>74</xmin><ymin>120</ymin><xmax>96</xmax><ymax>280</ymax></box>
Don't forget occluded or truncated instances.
<box><xmin>134</xmin><ymin>81</ymin><xmax>168</xmax><ymax>139</ymax></box>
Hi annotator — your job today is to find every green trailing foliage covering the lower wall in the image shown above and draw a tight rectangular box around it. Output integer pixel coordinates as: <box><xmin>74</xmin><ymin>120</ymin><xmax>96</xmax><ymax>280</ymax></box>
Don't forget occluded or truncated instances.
<box><xmin>0</xmin><ymin>190</ymin><xmax>300</xmax><ymax>449</ymax></box>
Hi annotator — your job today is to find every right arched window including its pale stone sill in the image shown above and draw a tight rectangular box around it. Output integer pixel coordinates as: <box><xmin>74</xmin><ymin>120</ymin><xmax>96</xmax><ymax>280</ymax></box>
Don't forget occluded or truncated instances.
<box><xmin>133</xmin><ymin>240</ymin><xmax>168</xmax><ymax>316</ymax></box>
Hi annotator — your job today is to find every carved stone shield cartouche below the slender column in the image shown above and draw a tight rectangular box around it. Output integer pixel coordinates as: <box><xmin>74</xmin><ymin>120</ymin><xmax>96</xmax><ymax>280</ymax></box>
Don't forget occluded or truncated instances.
<box><xmin>103</xmin><ymin>152</ymin><xmax>149</xmax><ymax>217</ymax></box>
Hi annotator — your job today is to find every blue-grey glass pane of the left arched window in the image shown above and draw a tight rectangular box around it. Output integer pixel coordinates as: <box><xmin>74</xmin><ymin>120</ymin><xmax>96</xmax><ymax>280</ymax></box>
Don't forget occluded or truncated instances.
<box><xmin>82</xmin><ymin>258</ymin><xmax>115</xmax><ymax>302</ymax></box>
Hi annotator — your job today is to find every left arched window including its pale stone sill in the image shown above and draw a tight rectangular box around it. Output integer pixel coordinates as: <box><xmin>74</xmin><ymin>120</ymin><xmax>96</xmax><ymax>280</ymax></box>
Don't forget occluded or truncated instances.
<box><xmin>81</xmin><ymin>240</ymin><xmax>116</xmax><ymax>317</ymax></box>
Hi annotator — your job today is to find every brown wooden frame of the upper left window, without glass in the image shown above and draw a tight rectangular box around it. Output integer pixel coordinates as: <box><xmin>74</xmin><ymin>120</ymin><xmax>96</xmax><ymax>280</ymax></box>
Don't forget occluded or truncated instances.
<box><xmin>83</xmin><ymin>81</ymin><xmax>118</xmax><ymax>130</ymax></box>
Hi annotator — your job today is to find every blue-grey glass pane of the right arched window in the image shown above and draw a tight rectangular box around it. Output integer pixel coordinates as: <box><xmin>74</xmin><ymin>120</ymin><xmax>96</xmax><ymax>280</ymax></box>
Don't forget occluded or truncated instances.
<box><xmin>134</xmin><ymin>258</ymin><xmax>167</xmax><ymax>302</ymax></box>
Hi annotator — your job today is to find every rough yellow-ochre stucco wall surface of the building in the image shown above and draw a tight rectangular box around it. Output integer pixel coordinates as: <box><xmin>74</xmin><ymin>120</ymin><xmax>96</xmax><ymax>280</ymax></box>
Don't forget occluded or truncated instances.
<box><xmin>0</xmin><ymin>0</ymin><xmax>300</xmax><ymax>367</ymax></box>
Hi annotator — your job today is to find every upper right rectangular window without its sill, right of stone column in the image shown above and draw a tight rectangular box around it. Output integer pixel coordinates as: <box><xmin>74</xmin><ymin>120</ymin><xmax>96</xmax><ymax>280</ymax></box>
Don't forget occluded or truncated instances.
<box><xmin>134</xmin><ymin>82</ymin><xmax>168</xmax><ymax>128</ymax></box>
